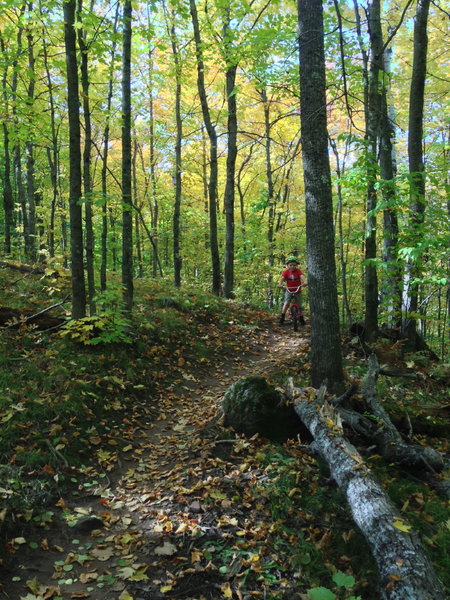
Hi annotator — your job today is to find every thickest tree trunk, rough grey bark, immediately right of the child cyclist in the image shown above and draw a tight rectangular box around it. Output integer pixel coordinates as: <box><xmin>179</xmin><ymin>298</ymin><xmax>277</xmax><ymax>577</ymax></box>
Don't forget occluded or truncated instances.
<box><xmin>298</xmin><ymin>0</ymin><xmax>343</xmax><ymax>391</ymax></box>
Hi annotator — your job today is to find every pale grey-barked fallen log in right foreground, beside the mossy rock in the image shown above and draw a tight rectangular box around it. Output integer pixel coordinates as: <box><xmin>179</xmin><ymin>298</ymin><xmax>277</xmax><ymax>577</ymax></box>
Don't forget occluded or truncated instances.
<box><xmin>287</xmin><ymin>382</ymin><xmax>446</xmax><ymax>600</ymax></box>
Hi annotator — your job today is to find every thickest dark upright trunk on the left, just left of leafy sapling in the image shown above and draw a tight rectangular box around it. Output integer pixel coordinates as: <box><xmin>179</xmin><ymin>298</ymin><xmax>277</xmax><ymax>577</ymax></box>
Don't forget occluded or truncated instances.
<box><xmin>64</xmin><ymin>0</ymin><xmax>86</xmax><ymax>319</ymax></box>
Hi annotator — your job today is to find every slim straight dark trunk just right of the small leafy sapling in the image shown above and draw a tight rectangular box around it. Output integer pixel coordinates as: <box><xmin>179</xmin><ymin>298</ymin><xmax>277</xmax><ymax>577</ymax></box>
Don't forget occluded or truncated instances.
<box><xmin>122</xmin><ymin>0</ymin><xmax>133</xmax><ymax>314</ymax></box>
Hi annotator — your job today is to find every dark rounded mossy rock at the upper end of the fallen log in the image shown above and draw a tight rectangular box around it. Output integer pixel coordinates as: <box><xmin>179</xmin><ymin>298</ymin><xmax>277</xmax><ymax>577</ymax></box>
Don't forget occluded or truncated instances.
<box><xmin>223</xmin><ymin>377</ymin><xmax>303</xmax><ymax>441</ymax></box>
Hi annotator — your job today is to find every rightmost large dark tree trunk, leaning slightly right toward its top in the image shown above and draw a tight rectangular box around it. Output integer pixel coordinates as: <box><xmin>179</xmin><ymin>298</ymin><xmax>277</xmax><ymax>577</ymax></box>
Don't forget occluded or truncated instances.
<box><xmin>403</xmin><ymin>0</ymin><xmax>430</xmax><ymax>349</ymax></box>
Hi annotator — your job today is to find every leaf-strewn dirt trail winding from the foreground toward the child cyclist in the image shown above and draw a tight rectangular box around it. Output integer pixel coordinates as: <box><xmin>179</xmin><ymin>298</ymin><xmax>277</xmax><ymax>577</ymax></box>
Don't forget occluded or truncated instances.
<box><xmin>0</xmin><ymin>327</ymin><xmax>308</xmax><ymax>600</ymax></box>
